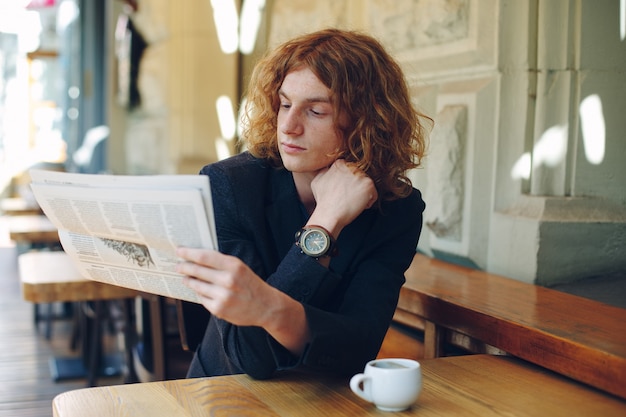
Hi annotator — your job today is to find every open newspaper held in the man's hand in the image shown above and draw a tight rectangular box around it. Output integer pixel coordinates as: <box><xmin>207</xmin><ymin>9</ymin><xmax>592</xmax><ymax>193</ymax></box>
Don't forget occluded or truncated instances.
<box><xmin>29</xmin><ymin>169</ymin><xmax>218</xmax><ymax>303</ymax></box>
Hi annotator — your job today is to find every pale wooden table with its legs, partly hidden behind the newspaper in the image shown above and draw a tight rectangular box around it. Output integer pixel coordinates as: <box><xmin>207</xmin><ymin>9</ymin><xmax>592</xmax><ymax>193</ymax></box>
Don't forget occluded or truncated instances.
<box><xmin>18</xmin><ymin>251</ymin><xmax>140</xmax><ymax>386</ymax></box>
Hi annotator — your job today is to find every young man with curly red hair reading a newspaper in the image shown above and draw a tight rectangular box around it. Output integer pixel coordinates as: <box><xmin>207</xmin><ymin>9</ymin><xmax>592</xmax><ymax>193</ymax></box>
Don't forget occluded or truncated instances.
<box><xmin>178</xmin><ymin>29</ymin><xmax>429</xmax><ymax>379</ymax></box>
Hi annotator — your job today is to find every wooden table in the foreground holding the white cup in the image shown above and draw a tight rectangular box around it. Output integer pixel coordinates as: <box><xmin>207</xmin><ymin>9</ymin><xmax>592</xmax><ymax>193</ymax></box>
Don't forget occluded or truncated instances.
<box><xmin>53</xmin><ymin>355</ymin><xmax>626</xmax><ymax>417</ymax></box>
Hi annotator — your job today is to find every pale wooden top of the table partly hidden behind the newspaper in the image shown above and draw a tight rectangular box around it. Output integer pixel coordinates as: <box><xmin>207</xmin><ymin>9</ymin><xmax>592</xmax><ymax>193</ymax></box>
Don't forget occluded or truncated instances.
<box><xmin>18</xmin><ymin>251</ymin><xmax>140</xmax><ymax>303</ymax></box>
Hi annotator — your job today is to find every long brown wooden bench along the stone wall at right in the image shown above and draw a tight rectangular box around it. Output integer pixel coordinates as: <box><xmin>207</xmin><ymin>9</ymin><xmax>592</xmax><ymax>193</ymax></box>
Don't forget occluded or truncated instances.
<box><xmin>394</xmin><ymin>254</ymin><xmax>626</xmax><ymax>399</ymax></box>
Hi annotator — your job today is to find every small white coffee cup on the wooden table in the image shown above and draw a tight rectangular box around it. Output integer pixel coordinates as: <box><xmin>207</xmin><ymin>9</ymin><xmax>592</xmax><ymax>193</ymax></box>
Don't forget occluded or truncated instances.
<box><xmin>350</xmin><ymin>358</ymin><xmax>422</xmax><ymax>411</ymax></box>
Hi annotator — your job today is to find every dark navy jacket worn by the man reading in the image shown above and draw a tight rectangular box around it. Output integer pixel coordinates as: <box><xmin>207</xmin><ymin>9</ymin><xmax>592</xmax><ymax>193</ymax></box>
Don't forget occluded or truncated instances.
<box><xmin>188</xmin><ymin>153</ymin><xmax>425</xmax><ymax>379</ymax></box>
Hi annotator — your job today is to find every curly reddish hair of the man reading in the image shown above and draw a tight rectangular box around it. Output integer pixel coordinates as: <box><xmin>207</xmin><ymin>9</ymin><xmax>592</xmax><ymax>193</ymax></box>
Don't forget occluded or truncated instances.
<box><xmin>241</xmin><ymin>29</ymin><xmax>432</xmax><ymax>200</ymax></box>
